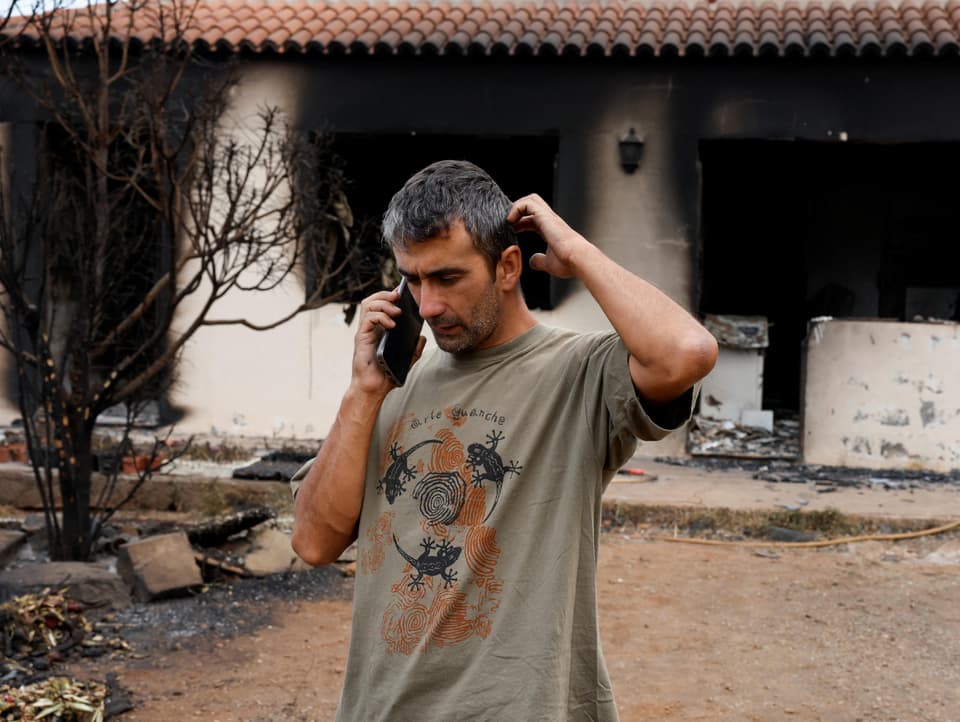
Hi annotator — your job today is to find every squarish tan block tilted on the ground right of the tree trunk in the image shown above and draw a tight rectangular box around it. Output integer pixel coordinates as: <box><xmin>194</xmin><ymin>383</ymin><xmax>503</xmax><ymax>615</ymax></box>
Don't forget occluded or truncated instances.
<box><xmin>117</xmin><ymin>531</ymin><xmax>203</xmax><ymax>601</ymax></box>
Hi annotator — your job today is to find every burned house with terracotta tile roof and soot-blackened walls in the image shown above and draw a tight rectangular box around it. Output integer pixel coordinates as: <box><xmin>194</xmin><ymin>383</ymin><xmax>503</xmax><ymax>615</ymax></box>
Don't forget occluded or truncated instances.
<box><xmin>0</xmin><ymin>0</ymin><xmax>960</xmax><ymax>471</ymax></box>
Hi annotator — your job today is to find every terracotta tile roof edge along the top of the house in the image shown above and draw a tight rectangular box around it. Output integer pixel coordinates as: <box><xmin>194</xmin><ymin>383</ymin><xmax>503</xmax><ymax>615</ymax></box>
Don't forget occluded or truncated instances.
<box><xmin>9</xmin><ymin>0</ymin><xmax>960</xmax><ymax>57</ymax></box>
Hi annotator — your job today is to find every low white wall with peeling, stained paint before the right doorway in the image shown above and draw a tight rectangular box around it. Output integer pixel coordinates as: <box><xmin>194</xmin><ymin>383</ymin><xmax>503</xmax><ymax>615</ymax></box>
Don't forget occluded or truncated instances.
<box><xmin>803</xmin><ymin>320</ymin><xmax>960</xmax><ymax>472</ymax></box>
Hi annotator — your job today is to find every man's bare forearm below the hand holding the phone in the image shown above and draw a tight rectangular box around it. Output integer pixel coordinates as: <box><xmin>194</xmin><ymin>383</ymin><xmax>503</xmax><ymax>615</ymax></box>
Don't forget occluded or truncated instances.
<box><xmin>292</xmin><ymin>389</ymin><xmax>383</xmax><ymax>565</ymax></box>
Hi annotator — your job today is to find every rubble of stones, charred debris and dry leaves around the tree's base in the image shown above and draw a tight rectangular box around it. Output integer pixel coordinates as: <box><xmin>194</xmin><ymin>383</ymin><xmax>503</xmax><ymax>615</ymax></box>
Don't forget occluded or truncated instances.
<box><xmin>0</xmin><ymin>507</ymin><xmax>344</xmax><ymax>722</ymax></box>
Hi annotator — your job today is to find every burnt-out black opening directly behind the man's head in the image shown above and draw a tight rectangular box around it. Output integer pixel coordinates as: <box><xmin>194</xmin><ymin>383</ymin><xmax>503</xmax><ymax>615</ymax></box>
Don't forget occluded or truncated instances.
<box><xmin>334</xmin><ymin>133</ymin><xmax>557</xmax><ymax>309</ymax></box>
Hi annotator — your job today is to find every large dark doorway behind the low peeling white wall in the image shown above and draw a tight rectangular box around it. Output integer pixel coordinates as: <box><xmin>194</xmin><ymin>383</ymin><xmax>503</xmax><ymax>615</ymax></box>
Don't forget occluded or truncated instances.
<box><xmin>700</xmin><ymin>140</ymin><xmax>960</xmax><ymax>412</ymax></box>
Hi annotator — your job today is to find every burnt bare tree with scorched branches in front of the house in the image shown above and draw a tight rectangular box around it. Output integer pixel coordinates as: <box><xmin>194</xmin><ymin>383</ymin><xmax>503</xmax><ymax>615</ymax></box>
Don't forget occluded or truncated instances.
<box><xmin>0</xmin><ymin>0</ymin><xmax>379</xmax><ymax>559</ymax></box>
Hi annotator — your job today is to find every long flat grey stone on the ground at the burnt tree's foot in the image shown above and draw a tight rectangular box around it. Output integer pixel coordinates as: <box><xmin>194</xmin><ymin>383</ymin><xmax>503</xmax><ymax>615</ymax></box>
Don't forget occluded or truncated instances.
<box><xmin>0</xmin><ymin>562</ymin><xmax>130</xmax><ymax>611</ymax></box>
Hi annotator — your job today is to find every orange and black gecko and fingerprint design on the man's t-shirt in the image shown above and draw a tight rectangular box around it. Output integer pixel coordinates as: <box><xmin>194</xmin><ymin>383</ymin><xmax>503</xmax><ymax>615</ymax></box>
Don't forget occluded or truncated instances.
<box><xmin>378</xmin><ymin>416</ymin><xmax>523</xmax><ymax>655</ymax></box>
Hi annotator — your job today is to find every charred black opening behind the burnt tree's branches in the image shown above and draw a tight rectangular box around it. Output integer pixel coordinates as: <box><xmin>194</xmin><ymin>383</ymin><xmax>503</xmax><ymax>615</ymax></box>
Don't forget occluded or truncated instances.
<box><xmin>38</xmin><ymin>123</ymin><xmax>173</xmax><ymax>416</ymax></box>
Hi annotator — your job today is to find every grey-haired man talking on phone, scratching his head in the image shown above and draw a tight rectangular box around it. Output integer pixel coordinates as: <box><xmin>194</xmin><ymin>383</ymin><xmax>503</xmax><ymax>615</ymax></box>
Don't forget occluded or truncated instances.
<box><xmin>293</xmin><ymin>161</ymin><xmax>717</xmax><ymax>722</ymax></box>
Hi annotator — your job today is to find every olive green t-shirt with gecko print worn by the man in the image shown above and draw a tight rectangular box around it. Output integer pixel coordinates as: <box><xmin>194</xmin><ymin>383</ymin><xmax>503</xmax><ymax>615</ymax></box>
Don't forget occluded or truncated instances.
<box><xmin>294</xmin><ymin>325</ymin><xmax>692</xmax><ymax>722</ymax></box>
